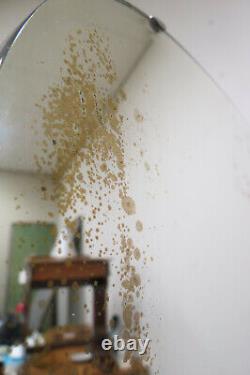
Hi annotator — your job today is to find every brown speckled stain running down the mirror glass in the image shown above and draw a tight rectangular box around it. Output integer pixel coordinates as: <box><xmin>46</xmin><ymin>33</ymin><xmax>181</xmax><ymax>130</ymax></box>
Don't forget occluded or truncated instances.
<box><xmin>35</xmin><ymin>30</ymin><xmax>151</xmax><ymax>368</ymax></box>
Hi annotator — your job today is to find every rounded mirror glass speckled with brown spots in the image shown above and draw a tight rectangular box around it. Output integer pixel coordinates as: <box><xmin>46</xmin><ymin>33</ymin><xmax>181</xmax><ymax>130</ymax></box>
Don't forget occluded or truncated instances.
<box><xmin>0</xmin><ymin>0</ymin><xmax>250</xmax><ymax>375</ymax></box>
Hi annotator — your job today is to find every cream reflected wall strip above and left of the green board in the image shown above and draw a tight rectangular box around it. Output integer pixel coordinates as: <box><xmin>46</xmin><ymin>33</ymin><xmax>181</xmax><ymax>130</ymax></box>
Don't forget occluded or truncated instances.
<box><xmin>0</xmin><ymin>171</ymin><xmax>56</xmax><ymax>311</ymax></box>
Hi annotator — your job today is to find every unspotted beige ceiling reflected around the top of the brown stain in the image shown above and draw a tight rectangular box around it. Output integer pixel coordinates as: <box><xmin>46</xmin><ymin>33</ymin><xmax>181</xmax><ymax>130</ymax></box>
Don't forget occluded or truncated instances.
<box><xmin>0</xmin><ymin>0</ymin><xmax>164</xmax><ymax>174</ymax></box>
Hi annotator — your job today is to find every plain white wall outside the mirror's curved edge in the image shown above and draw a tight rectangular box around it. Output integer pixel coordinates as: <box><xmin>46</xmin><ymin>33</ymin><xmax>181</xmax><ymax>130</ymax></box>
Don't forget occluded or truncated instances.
<box><xmin>131</xmin><ymin>0</ymin><xmax>250</xmax><ymax>126</ymax></box>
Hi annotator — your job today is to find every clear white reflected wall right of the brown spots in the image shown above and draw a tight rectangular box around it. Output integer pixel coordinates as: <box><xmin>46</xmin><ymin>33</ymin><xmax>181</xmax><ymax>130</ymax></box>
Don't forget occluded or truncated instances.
<box><xmin>116</xmin><ymin>36</ymin><xmax>250</xmax><ymax>375</ymax></box>
